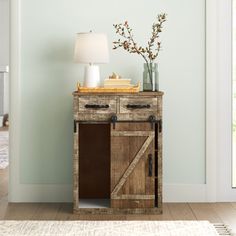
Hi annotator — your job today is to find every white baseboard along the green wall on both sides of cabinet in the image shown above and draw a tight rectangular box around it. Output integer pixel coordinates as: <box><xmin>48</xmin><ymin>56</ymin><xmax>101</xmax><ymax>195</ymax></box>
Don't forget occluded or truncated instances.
<box><xmin>9</xmin><ymin>184</ymin><xmax>206</xmax><ymax>202</ymax></box>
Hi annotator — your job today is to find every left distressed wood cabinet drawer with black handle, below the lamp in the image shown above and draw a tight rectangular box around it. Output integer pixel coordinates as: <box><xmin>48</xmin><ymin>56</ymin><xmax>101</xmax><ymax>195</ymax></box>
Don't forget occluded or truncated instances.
<box><xmin>77</xmin><ymin>96</ymin><xmax>116</xmax><ymax>113</ymax></box>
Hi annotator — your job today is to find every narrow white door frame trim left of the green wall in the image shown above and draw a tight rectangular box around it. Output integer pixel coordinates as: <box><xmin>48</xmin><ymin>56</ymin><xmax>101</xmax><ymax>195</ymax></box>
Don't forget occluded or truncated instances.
<box><xmin>8</xmin><ymin>0</ymin><xmax>21</xmax><ymax>202</ymax></box>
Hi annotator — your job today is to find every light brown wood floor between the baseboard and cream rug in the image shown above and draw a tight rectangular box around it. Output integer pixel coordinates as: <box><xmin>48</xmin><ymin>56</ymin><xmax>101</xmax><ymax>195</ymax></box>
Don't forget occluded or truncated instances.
<box><xmin>0</xmin><ymin>169</ymin><xmax>236</xmax><ymax>232</ymax></box>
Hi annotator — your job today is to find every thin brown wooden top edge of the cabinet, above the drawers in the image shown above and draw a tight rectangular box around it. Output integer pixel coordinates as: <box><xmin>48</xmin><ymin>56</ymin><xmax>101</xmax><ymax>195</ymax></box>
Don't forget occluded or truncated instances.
<box><xmin>73</xmin><ymin>91</ymin><xmax>164</xmax><ymax>96</ymax></box>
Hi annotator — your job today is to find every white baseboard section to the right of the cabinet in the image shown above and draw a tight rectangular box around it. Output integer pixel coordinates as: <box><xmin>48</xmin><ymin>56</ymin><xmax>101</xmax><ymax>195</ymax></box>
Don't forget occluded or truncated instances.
<box><xmin>163</xmin><ymin>184</ymin><xmax>207</xmax><ymax>202</ymax></box>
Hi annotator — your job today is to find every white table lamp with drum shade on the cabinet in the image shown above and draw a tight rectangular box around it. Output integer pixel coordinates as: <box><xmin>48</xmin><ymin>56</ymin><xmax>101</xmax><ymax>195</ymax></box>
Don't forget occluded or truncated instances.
<box><xmin>74</xmin><ymin>32</ymin><xmax>109</xmax><ymax>88</ymax></box>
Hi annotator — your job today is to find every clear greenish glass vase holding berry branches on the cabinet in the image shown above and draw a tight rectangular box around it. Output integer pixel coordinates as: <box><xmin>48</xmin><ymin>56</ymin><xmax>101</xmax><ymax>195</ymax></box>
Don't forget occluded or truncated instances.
<box><xmin>143</xmin><ymin>63</ymin><xmax>159</xmax><ymax>91</ymax></box>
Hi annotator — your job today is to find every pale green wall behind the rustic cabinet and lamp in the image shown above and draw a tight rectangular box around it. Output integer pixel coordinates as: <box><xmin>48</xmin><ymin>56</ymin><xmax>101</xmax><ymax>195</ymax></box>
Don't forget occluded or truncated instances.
<box><xmin>20</xmin><ymin>0</ymin><xmax>205</xmax><ymax>184</ymax></box>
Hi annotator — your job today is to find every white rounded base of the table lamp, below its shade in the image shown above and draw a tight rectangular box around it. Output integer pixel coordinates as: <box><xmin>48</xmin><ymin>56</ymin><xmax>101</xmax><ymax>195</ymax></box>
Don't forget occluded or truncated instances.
<box><xmin>83</xmin><ymin>65</ymin><xmax>100</xmax><ymax>88</ymax></box>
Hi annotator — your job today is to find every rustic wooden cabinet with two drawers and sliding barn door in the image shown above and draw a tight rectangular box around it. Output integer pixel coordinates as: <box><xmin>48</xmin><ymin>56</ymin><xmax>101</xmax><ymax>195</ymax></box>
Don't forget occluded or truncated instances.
<box><xmin>73</xmin><ymin>92</ymin><xmax>163</xmax><ymax>214</ymax></box>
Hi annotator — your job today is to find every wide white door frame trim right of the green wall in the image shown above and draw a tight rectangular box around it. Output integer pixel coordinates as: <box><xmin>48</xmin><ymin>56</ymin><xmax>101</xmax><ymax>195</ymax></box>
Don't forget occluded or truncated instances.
<box><xmin>206</xmin><ymin>0</ymin><xmax>236</xmax><ymax>202</ymax></box>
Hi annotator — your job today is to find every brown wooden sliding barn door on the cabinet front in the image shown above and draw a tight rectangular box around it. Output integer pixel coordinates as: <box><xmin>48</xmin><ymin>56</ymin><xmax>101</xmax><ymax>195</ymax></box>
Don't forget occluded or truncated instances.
<box><xmin>111</xmin><ymin>123</ymin><xmax>155</xmax><ymax>208</ymax></box>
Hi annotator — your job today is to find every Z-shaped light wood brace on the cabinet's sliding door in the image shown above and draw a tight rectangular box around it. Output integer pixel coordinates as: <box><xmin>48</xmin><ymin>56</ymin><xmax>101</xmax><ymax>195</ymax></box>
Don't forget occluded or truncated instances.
<box><xmin>111</xmin><ymin>131</ymin><xmax>155</xmax><ymax>199</ymax></box>
